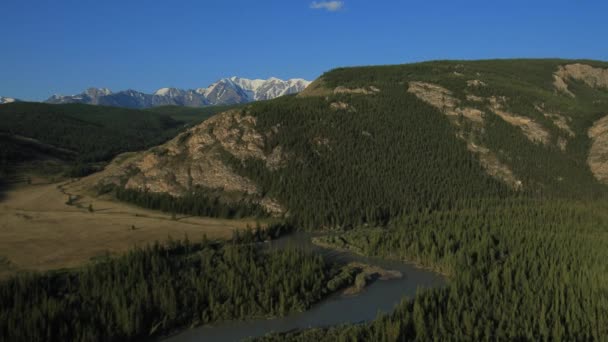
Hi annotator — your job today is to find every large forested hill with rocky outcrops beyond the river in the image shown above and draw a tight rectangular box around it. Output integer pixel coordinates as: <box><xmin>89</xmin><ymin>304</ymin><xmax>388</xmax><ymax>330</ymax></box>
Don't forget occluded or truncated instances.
<box><xmin>86</xmin><ymin>60</ymin><xmax>608</xmax><ymax>226</ymax></box>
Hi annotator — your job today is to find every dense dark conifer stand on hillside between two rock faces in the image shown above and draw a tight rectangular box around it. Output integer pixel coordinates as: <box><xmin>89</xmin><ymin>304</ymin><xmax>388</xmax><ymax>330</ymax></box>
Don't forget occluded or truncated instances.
<box><xmin>232</xmin><ymin>85</ymin><xmax>510</xmax><ymax>227</ymax></box>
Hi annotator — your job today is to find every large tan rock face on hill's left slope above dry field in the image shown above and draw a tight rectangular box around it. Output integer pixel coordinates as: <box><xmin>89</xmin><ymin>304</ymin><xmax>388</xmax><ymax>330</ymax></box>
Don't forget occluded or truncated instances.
<box><xmin>83</xmin><ymin>110</ymin><xmax>288</xmax><ymax>215</ymax></box>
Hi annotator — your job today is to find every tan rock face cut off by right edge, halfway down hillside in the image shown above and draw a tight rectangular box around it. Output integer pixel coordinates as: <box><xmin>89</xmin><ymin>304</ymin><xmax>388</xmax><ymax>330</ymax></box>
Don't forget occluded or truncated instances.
<box><xmin>587</xmin><ymin>116</ymin><xmax>608</xmax><ymax>184</ymax></box>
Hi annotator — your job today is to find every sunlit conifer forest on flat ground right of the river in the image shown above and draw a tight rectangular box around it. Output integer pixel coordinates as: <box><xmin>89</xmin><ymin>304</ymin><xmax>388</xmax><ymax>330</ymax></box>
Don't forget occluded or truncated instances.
<box><xmin>264</xmin><ymin>199</ymin><xmax>608</xmax><ymax>341</ymax></box>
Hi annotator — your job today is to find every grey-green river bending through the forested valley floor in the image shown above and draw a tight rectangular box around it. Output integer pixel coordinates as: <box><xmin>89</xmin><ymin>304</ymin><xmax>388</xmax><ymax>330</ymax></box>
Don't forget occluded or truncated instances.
<box><xmin>165</xmin><ymin>233</ymin><xmax>445</xmax><ymax>342</ymax></box>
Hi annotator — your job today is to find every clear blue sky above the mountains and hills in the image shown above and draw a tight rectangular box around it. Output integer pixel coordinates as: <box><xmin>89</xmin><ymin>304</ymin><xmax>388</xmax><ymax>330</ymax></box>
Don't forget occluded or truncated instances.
<box><xmin>0</xmin><ymin>0</ymin><xmax>608</xmax><ymax>100</ymax></box>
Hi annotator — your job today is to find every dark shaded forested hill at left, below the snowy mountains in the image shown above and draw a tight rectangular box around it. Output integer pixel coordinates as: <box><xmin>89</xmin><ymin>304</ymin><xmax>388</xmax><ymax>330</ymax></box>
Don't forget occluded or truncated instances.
<box><xmin>0</xmin><ymin>102</ymin><xmax>235</xmax><ymax>178</ymax></box>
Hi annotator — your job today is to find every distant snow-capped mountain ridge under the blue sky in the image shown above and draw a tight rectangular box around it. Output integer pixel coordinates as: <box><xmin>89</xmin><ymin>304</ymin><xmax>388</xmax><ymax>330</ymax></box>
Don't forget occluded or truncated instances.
<box><xmin>45</xmin><ymin>76</ymin><xmax>310</xmax><ymax>108</ymax></box>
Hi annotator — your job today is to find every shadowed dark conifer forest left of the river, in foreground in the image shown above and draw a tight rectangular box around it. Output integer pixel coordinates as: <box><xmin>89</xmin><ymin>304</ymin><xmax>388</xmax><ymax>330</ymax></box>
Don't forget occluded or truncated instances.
<box><xmin>0</xmin><ymin>235</ymin><xmax>346</xmax><ymax>341</ymax></box>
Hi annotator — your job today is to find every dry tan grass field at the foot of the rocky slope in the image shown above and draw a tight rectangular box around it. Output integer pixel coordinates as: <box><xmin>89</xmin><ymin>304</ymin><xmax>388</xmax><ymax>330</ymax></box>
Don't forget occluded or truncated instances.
<box><xmin>0</xmin><ymin>181</ymin><xmax>256</xmax><ymax>277</ymax></box>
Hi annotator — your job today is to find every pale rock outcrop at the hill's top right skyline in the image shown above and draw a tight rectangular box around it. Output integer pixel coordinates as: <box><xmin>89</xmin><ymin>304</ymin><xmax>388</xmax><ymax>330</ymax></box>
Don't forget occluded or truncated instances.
<box><xmin>553</xmin><ymin>63</ymin><xmax>608</xmax><ymax>97</ymax></box>
